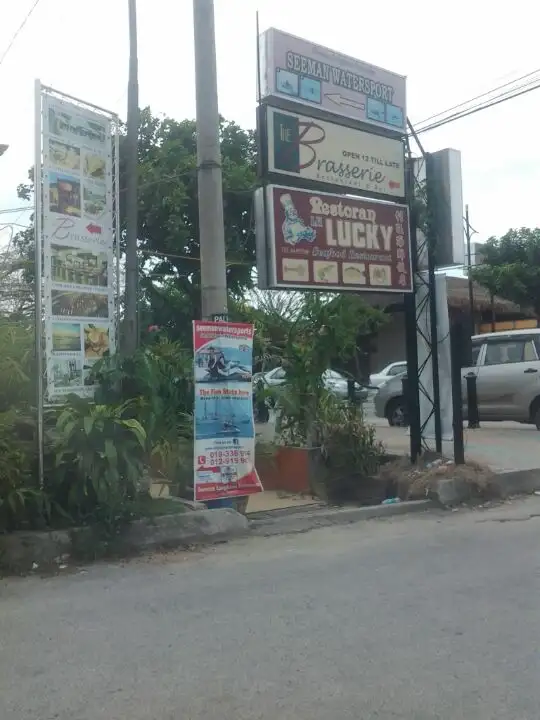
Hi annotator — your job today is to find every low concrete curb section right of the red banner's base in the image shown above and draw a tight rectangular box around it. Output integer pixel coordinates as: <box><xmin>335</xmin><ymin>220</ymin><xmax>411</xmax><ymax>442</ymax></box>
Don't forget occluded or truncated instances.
<box><xmin>250</xmin><ymin>500</ymin><xmax>435</xmax><ymax>537</ymax></box>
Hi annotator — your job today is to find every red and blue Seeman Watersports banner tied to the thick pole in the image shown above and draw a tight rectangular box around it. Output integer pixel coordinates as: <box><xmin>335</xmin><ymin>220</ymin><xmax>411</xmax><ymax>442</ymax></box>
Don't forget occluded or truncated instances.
<box><xmin>193</xmin><ymin>320</ymin><xmax>263</xmax><ymax>501</ymax></box>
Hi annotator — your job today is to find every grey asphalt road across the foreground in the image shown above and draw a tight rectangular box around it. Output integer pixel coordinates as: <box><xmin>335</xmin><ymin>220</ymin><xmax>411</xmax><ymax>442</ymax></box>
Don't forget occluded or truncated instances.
<box><xmin>0</xmin><ymin>497</ymin><xmax>540</xmax><ymax>720</ymax></box>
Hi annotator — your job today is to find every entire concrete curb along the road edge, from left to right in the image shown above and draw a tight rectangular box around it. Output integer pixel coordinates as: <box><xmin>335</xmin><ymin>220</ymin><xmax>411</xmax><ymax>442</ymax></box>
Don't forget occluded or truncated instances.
<box><xmin>10</xmin><ymin>478</ymin><xmax>540</xmax><ymax>573</ymax></box>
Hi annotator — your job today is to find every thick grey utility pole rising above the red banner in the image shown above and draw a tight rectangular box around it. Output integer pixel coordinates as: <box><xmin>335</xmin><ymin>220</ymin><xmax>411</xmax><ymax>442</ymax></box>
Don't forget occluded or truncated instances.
<box><xmin>193</xmin><ymin>0</ymin><xmax>227</xmax><ymax>320</ymax></box>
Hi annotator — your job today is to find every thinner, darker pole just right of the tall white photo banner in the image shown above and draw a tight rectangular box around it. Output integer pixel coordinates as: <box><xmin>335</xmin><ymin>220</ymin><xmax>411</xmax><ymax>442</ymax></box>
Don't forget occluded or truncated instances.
<box><xmin>124</xmin><ymin>0</ymin><xmax>139</xmax><ymax>354</ymax></box>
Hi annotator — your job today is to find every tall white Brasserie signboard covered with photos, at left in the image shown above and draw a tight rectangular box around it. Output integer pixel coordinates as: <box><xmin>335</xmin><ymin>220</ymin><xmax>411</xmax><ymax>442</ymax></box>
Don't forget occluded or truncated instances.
<box><xmin>42</xmin><ymin>93</ymin><xmax>115</xmax><ymax>402</ymax></box>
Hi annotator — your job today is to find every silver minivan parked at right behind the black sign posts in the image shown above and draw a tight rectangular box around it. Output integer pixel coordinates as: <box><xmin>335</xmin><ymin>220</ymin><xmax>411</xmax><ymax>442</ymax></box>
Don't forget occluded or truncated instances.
<box><xmin>374</xmin><ymin>329</ymin><xmax>540</xmax><ymax>430</ymax></box>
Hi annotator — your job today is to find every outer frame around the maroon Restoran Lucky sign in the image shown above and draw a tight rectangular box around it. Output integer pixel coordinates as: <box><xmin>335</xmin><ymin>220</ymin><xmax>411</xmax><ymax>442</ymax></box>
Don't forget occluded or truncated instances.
<box><xmin>255</xmin><ymin>184</ymin><xmax>414</xmax><ymax>295</ymax></box>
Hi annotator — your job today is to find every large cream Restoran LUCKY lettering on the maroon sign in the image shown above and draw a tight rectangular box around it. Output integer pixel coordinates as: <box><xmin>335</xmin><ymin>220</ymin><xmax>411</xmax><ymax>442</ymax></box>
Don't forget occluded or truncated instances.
<box><xmin>309</xmin><ymin>196</ymin><xmax>395</xmax><ymax>252</ymax></box>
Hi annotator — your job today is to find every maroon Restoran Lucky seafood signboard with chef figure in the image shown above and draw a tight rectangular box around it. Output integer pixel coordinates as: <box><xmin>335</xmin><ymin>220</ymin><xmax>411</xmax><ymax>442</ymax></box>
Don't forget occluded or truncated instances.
<box><xmin>256</xmin><ymin>185</ymin><xmax>412</xmax><ymax>293</ymax></box>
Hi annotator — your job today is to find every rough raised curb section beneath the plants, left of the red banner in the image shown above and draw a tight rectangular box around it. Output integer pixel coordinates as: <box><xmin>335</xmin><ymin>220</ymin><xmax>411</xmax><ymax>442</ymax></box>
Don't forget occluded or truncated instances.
<box><xmin>0</xmin><ymin>508</ymin><xmax>249</xmax><ymax>574</ymax></box>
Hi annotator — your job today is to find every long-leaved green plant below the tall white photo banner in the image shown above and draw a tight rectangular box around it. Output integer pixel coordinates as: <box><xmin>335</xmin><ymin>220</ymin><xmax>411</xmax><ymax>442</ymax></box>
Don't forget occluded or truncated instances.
<box><xmin>47</xmin><ymin>395</ymin><xmax>146</xmax><ymax>521</ymax></box>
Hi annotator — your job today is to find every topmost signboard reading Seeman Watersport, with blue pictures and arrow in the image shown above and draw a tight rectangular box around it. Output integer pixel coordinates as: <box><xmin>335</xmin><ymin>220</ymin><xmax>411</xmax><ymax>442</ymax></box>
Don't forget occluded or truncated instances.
<box><xmin>259</xmin><ymin>28</ymin><xmax>407</xmax><ymax>134</ymax></box>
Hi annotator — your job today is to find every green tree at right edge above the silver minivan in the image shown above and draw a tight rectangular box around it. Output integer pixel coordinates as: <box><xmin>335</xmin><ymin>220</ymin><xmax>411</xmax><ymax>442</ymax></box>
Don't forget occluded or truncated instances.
<box><xmin>472</xmin><ymin>228</ymin><xmax>540</xmax><ymax>316</ymax></box>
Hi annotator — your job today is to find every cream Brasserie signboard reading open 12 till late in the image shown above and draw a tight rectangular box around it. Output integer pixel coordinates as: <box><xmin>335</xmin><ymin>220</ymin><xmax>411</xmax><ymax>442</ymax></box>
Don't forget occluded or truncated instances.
<box><xmin>266</xmin><ymin>107</ymin><xmax>405</xmax><ymax>198</ymax></box>
